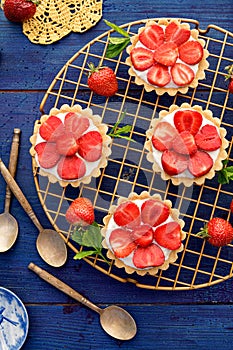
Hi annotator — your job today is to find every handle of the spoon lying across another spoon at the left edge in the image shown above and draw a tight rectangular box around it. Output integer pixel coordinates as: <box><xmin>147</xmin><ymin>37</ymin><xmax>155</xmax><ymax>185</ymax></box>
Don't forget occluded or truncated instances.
<box><xmin>0</xmin><ymin>158</ymin><xmax>43</xmax><ymax>232</ymax></box>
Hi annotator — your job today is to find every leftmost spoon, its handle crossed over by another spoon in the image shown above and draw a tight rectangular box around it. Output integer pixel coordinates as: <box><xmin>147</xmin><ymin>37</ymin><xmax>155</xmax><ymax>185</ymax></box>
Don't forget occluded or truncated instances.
<box><xmin>0</xmin><ymin>128</ymin><xmax>20</xmax><ymax>253</ymax></box>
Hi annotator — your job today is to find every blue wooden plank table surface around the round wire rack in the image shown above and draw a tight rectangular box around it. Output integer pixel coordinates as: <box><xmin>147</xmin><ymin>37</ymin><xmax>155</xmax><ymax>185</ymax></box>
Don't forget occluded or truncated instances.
<box><xmin>0</xmin><ymin>0</ymin><xmax>233</xmax><ymax>350</ymax></box>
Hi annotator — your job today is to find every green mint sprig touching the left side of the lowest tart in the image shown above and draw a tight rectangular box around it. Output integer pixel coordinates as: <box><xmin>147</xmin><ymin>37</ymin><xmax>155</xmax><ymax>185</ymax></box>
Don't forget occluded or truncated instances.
<box><xmin>72</xmin><ymin>222</ymin><xmax>109</xmax><ymax>264</ymax></box>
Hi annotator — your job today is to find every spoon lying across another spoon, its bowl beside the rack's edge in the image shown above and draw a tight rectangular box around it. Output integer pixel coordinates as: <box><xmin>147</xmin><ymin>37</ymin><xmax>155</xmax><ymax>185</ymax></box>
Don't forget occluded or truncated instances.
<box><xmin>0</xmin><ymin>158</ymin><xmax>67</xmax><ymax>267</ymax></box>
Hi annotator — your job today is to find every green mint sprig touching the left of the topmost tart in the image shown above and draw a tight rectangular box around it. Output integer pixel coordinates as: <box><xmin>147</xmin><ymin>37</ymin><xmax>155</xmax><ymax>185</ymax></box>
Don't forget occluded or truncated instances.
<box><xmin>104</xmin><ymin>20</ymin><xmax>130</xmax><ymax>58</ymax></box>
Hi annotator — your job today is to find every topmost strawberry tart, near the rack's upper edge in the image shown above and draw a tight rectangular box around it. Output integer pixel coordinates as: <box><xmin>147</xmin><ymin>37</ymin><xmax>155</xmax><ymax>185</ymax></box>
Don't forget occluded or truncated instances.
<box><xmin>126</xmin><ymin>19</ymin><xmax>209</xmax><ymax>96</ymax></box>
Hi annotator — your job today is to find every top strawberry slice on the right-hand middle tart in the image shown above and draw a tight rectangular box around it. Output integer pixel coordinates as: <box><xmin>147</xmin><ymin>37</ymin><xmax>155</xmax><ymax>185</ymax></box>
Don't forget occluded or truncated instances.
<box><xmin>174</xmin><ymin>109</ymin><xmax>202</xmax><ymax>135</ymax></box>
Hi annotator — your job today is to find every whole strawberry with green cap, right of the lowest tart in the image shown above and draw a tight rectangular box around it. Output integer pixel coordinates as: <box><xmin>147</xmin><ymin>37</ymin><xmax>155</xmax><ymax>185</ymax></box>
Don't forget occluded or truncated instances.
<box><xmin>198</xmin><ymin>217</ymin><xmax>233</xmax><ymax>247</ymax></box>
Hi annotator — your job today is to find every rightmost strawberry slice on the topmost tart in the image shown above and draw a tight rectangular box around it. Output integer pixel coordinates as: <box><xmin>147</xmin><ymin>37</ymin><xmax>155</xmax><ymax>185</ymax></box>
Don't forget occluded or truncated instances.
<box><xmin>179</xmin><ymin>40</ymin><xmax>204</xmax><ymax>65</ymax></box>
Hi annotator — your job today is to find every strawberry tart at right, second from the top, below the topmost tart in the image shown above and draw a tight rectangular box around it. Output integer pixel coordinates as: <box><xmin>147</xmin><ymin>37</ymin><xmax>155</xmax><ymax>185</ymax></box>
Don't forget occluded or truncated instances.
<box><xmin>145</xmin><ymin>103</ymin><xmax>229</xmax><ymax>187</ymax></box>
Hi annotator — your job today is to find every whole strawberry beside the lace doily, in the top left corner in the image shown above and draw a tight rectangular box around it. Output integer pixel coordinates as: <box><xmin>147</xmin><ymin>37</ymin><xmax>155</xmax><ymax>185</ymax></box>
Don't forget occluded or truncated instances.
<box><xmin>3</xmin><ymin>0</ymin><xmax>39</xmax><ymax>22</ymax></box>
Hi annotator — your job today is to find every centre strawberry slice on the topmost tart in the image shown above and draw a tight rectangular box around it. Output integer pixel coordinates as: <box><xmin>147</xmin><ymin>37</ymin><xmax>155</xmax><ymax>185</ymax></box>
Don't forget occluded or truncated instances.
<box><xmin>154</xmin><ymin>42</ymin><xmax>178</xmax><ymax>66</ymax></box>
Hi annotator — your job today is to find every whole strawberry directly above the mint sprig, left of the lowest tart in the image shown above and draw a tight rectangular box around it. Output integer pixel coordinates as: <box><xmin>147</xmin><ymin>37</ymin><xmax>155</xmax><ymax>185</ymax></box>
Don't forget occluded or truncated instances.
<box><xmin>66</xmin><ymin>197</ymin><xmax>95</xmax><ymax>226</ymax></box>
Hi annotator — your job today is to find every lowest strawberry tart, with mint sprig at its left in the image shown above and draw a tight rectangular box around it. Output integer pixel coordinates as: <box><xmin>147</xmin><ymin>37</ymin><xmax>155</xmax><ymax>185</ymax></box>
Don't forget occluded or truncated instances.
<box><xmin>101</xmin><ymin>191</ymin><xmax>185</xmax><ymax>275</ymax></box>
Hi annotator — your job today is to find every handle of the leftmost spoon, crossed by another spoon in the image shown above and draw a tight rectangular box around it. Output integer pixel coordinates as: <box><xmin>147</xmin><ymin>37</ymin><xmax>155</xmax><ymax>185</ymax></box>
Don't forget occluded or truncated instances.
<box><xmin>5</xmin><ymin>128</ymin><xmax>21</xmax><ymax>213</ymax></box>
